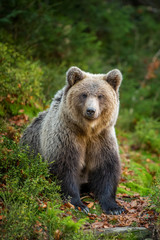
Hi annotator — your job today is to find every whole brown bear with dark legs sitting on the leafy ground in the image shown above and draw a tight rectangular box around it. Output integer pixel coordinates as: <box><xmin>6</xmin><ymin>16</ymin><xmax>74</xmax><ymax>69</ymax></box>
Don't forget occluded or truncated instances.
<box><xmin>21</xmin><ymin>67</ymin><xmax>124</xmax><ymax>214</ymax></box>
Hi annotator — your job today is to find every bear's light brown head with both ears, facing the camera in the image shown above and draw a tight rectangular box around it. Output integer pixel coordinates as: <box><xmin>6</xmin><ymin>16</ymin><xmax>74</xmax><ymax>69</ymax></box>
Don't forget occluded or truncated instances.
<box><xmin>65</xmin><ymin>67</ymin><xmax>122</xmax><ymax>133</ymax></box>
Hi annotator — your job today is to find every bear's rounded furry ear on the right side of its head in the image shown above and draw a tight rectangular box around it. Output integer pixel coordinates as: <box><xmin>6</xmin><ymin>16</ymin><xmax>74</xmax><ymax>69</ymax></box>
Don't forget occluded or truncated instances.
<box><xmin>104</xmin><ymin>69</ymin><xmax>122</xmax><ymax>92</ymax></box>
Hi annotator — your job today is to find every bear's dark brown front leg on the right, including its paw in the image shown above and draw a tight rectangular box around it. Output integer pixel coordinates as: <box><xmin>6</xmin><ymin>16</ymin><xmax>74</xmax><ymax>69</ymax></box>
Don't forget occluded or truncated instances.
<box><xmin>89</xmin><ymin>151</ymin><xmax>125</xmax><ymax>215</ymax></box>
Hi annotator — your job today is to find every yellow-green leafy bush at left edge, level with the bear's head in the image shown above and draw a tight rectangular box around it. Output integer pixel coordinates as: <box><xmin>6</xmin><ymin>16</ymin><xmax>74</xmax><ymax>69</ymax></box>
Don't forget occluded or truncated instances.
<box><xmin>0</xmin><ymin>43</ymin><xmax>43</xmax><ymax>116</ymax></box>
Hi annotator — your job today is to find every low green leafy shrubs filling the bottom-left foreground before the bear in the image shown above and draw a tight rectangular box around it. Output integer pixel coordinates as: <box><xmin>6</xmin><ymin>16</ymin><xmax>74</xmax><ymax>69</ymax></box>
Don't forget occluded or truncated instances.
<box><xmin>0</xmin><ymin>138</ymin><xmax>85</xmax><ymax>239</ymax></box>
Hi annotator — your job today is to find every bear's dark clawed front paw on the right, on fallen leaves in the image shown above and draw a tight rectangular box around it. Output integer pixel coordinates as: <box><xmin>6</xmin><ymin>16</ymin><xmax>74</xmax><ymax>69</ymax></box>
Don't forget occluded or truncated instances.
<box><xmin>101</xmin><ymin>203</ymin><xmax>126</xmax><ymax>215</ymax></box>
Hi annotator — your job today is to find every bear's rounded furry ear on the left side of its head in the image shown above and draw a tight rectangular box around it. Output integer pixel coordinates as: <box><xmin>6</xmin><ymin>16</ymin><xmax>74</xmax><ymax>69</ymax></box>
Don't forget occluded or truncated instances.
<box><xmin>66</xmin><ymin>67</ymin><xmax>84</xmax><ymax>86</ymax></box>
